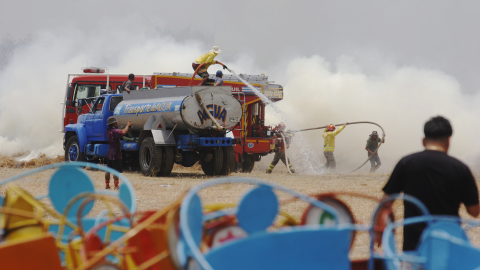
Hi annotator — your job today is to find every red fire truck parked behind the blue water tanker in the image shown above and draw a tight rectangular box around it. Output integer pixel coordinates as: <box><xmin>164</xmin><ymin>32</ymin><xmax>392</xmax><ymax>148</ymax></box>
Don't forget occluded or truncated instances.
<box><xmin>61</xmin><ymin>68</ymin><xmax>283</xmax><ymax>172</ymax></box>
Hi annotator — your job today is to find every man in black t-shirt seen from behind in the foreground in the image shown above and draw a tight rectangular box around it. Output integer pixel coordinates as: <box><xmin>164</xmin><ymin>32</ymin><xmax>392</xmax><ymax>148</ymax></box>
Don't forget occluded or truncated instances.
<box><xmin>383</xmin><ymin>116</ymin><xmax>479</xmax><ymax>250</ymax></box>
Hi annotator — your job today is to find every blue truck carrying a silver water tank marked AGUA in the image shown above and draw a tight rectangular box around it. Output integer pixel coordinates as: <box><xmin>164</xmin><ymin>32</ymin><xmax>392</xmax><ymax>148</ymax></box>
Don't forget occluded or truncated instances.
<box><xmin>64</xmin><ymin>86</ymin><xmax>243</xmax><ymax>176</ymax></box>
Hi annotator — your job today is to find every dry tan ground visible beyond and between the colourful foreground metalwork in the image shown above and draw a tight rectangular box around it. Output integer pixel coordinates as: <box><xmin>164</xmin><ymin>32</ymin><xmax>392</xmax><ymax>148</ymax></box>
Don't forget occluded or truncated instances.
<box><xmin>0</xmin><ymin>166</ymin><xmax>480</xmax><ymax>258</ymax></box>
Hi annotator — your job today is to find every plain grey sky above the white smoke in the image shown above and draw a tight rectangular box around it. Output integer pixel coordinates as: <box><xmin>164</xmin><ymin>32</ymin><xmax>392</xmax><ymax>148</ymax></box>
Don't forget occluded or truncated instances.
<box><xmin>0</xmin><ymin>0</ymin><xmax>480</xmax><ymax>92</ymax></box>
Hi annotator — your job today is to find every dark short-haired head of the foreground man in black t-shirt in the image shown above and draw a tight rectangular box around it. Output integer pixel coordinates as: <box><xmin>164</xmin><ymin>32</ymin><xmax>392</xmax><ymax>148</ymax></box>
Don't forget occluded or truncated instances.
<box><xmin>423</xmin><ymin>116</ymin><xmax>453</xmax><ymax>152</ymax></box>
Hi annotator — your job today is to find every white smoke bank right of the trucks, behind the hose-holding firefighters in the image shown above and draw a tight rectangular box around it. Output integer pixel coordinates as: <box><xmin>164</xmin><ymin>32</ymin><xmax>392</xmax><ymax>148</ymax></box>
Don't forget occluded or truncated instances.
<box><xmin>275</xmin><ymin>55</ymin><xmax>480</xmax><ymax>172</ymax></box>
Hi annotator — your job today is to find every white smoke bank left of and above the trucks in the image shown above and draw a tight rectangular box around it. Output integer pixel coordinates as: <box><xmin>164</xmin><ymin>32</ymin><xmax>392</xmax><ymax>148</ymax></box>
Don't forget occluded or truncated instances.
<box><xmin>0</xmin><ymin>23</ymin><xmax>258</xmax><ymax>158</ymax></box>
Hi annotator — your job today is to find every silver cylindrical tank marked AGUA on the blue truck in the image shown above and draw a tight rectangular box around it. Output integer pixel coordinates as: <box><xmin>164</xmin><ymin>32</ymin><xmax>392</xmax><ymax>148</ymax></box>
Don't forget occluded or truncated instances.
<box><xmin>113</xmin><ymin>86</ymin><xmax>242</xmax><ymax>133</ymax></box>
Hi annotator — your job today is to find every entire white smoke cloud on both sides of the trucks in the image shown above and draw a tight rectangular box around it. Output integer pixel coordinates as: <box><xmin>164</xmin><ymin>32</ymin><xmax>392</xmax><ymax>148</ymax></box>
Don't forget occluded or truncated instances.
<box><xmin>0</xmin><ymin>23</ymin><xmax>480</xmax><ymax>172</ymax></box>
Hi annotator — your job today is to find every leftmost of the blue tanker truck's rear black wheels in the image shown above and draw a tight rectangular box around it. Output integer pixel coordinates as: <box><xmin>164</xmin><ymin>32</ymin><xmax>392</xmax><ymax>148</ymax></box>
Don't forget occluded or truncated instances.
<box><xmin>138</xmin><ymin>137</ymin><xmax>162</xmax><ymax>176</ymax></box>
